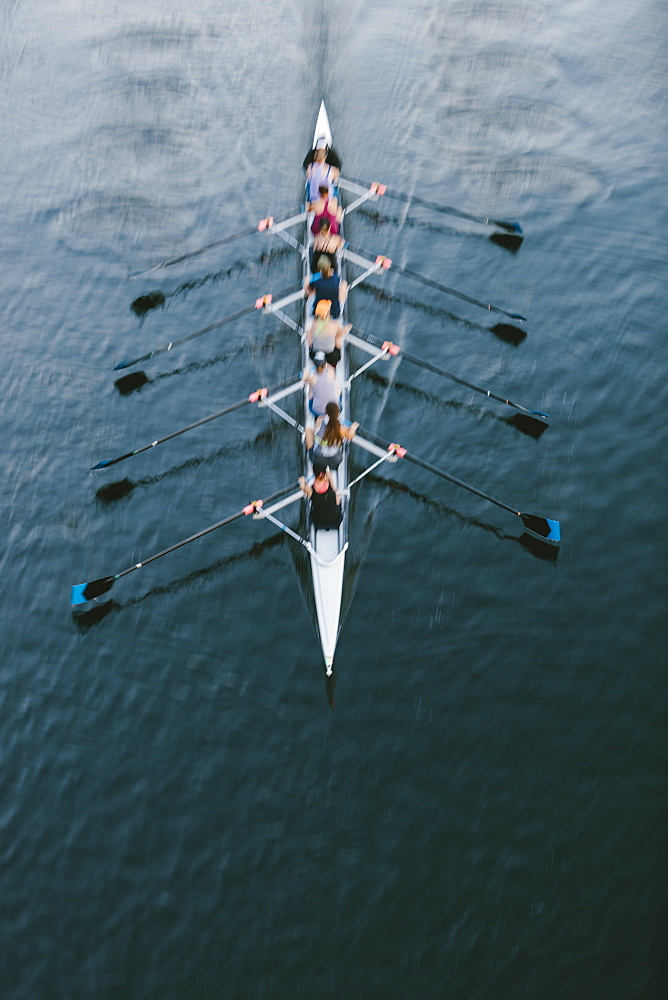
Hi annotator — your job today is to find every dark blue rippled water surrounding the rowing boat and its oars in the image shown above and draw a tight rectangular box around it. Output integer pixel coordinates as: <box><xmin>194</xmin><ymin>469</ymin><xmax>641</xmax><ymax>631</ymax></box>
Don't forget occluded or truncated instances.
<box><xmin>0</xmin><ymin>0</ymin><xmax>668</xmax><ymax>1000</ymax></box>
